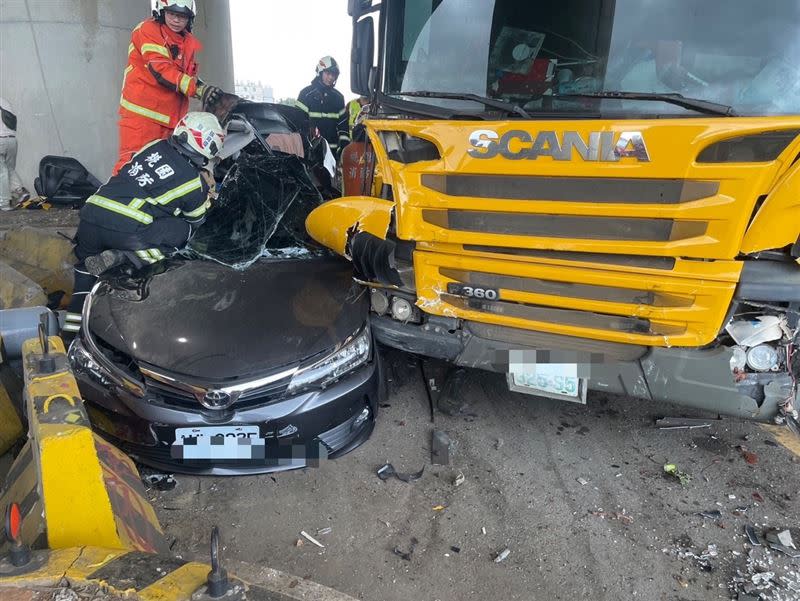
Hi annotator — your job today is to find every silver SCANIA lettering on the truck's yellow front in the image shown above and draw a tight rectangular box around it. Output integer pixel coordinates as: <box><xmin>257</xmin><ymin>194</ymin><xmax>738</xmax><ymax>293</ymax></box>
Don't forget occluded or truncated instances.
<box><xmin>467</xmin><ymin>129</ymin><xmax>650</xmax><ymax>163</ymax></box>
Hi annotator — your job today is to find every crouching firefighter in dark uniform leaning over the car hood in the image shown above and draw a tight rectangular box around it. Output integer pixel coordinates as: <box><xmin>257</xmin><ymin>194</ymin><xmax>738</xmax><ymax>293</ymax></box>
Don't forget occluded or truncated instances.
<box><xmin>63</xmin><ymin>113</ymin><xmax>225</xmax><ymax>336</ymax></box>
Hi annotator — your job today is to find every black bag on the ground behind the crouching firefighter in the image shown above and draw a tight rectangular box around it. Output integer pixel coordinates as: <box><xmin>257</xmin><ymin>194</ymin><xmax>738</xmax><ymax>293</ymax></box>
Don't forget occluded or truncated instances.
<box><xmin>33</xmin><ymin>156</ymin><xmax>102</xmax><ymax>209</ymax></box>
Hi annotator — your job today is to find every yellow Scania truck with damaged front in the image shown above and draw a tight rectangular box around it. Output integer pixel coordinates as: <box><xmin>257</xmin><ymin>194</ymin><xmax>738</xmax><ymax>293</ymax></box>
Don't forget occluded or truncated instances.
<box><xmin>307</xmin><ymin>0</ymin><xmax>800</xmax><ymax>427</ymax></box>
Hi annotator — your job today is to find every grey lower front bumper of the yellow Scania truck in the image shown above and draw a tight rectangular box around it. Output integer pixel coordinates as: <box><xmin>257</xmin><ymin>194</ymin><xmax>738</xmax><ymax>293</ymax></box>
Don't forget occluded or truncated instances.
<box><xmin>372</xmin><ymin>315</ymin><xmax>792</xmax><ymax>422</ymax></box>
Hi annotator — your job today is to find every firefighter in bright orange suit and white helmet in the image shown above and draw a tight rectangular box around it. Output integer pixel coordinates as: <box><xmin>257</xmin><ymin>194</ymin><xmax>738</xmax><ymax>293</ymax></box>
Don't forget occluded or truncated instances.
<box><xmin>114</xmin><ymin>0</ymin><xmax>222</xmax><ymax>175</ymax></box>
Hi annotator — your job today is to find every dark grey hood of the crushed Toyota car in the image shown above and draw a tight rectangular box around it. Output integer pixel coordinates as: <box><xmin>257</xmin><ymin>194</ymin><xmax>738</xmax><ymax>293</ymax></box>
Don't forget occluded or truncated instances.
<box><xmin>89</xmin><ymin>257</ymin><xmax>368</xmax><ymax>381</ymax></box>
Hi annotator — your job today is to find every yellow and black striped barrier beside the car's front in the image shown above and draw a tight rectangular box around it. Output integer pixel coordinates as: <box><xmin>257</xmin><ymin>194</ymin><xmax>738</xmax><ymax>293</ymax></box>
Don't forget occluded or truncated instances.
<box><xmin>0</xmin><ymin>337</ymin><xmax>167</xmax><ymax>553</ymax></box>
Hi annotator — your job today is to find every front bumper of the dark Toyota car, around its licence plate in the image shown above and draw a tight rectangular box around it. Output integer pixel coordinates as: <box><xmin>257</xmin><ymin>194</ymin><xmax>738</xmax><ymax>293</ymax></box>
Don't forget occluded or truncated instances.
<box><xmin>70</xmin><ymin>337</ymin><xmax>382</xmax><ymax>475</ymax></box>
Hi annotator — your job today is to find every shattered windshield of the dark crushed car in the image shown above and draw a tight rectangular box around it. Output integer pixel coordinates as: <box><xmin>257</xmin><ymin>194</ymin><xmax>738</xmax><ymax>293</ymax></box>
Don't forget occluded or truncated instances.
<box><xmin>187</xmin><ymin>153</ymin><xmax>327</xmax><ymax>269</ymax></box>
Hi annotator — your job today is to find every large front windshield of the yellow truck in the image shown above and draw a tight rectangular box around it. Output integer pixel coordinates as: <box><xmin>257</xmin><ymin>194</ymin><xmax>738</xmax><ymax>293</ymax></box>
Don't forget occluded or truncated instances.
<box><xmin>384</xmin><ymin>0</ymin><xmax>800</xmax><ymax>117</ymax></box>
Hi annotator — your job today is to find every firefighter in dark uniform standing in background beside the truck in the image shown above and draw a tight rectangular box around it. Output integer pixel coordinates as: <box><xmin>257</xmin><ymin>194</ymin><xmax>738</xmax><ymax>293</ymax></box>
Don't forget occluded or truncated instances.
<box><xmin>297</xmin><ymin>56</ymin><xmax>350</xmax><ymax>157</ymax></box>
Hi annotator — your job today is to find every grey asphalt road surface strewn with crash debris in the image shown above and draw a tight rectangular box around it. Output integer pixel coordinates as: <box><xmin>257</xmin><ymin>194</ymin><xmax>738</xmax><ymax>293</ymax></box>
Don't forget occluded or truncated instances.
<box><xmin>150</xmin><ymin>353</ymin><xmax>800</xmax><ymax>601</ymax></box>
